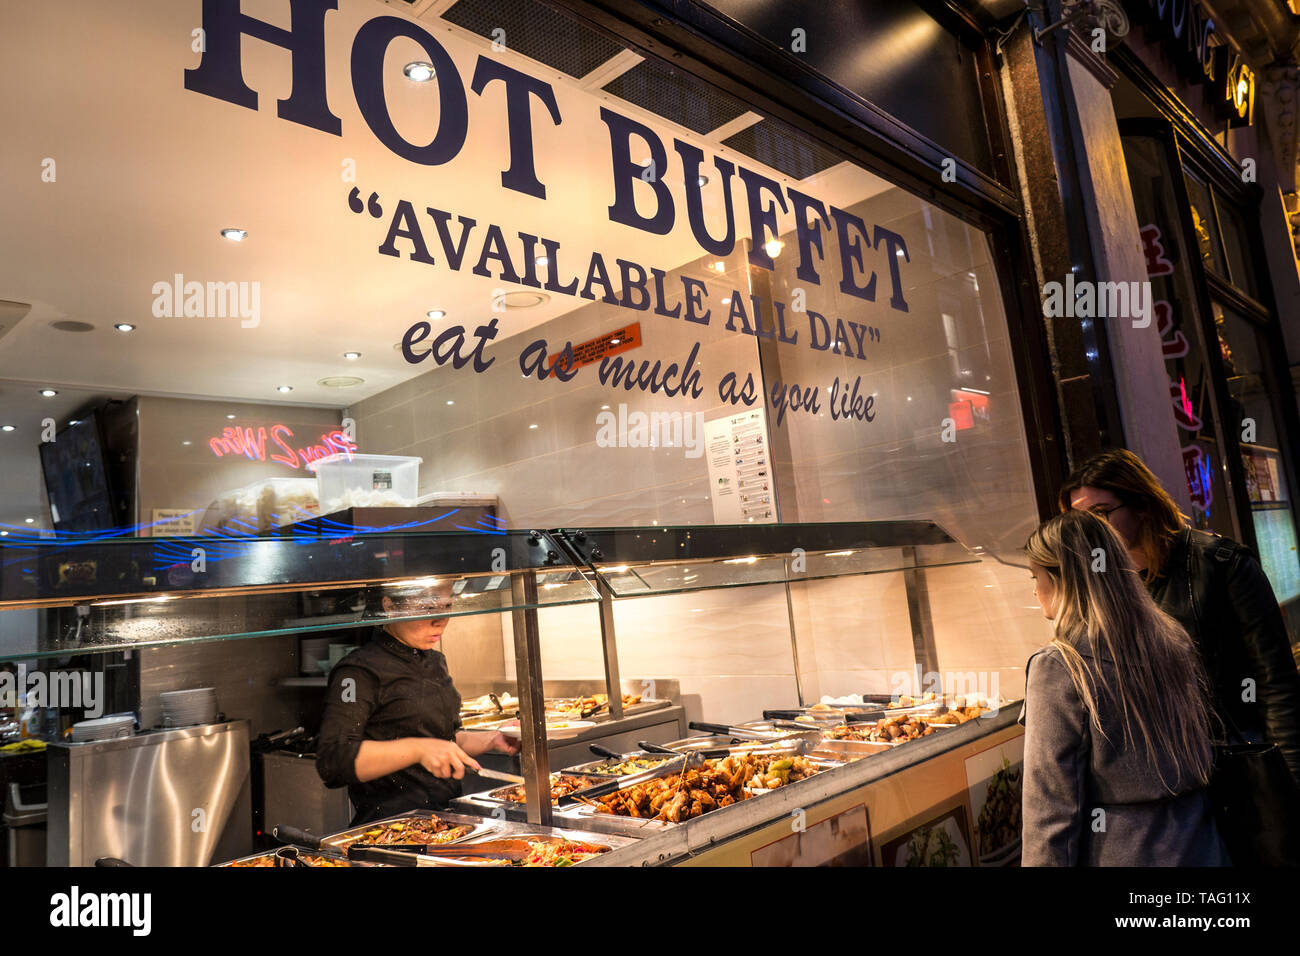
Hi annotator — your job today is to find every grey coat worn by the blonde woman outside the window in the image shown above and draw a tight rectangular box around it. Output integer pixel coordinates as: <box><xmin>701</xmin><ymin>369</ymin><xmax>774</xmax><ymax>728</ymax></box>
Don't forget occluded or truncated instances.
<box><xmin>1021</xmin><ymin>645</ymin><xmax>1231</xmax><ymax>866</ymax></box>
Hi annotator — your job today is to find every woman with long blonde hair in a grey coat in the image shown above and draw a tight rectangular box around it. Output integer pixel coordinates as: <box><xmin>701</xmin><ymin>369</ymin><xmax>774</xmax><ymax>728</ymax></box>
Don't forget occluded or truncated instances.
<box><xmin>1021</xmin><ymin>511</ymin><xmax>1229</xmax><ymax>866</ymax></box>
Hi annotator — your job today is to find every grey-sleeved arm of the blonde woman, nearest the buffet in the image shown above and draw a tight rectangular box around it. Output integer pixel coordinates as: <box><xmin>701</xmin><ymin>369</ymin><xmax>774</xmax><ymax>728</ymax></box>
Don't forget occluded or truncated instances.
<box><xmin>1021</xmin><ymin>649</ymin><xmax>1087</xmax><ymax>866</ymax></box>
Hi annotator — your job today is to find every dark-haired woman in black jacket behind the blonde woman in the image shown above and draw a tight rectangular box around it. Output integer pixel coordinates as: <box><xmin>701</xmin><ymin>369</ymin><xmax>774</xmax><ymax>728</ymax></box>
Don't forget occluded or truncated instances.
<box><xmin>1061</xmin><ymin>449</ymin><xmax>1300</xmax><ymax>784</ymax></box>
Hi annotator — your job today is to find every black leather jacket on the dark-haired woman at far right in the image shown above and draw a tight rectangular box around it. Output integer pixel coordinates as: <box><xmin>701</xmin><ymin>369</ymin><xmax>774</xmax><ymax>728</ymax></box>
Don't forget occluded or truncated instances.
<box><xmin>1151</xmin><ymin>528</ymin><xmax>1300</xmax><ymax>784</ymax></box>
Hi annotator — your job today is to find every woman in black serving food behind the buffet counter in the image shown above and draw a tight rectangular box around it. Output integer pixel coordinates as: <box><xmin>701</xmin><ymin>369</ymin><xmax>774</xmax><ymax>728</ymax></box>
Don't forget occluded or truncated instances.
<box><xmin>316</xmin><ymin>583</ymin><xmax>519</xmax><ymax>826</ymax></box>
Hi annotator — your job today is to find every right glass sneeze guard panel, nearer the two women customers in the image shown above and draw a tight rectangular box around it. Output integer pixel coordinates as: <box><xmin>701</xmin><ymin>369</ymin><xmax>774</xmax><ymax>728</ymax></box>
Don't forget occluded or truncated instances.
<box><xmin>560</xmin><ymin>522</ymin><xmax>980</xmax><ymax>597</ymax></box>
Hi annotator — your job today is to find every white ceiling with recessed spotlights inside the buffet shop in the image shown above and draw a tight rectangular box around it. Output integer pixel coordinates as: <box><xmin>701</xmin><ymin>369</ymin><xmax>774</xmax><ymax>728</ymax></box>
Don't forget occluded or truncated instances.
<box><xmin>0</xmin><ymin>0</ymin><xmax>887</xmax><ymax>522</ymax></box>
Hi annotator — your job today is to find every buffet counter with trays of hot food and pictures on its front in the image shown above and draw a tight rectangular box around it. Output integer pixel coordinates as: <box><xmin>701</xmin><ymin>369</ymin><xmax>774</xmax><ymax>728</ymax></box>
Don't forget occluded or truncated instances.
<box><xmin>239</xmin><ymin>701</ymin><xmax>1023</xmax><ymax>866</ymax></box>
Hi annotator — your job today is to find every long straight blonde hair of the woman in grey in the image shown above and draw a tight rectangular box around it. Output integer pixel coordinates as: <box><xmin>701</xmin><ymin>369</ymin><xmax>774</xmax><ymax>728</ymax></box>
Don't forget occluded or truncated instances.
<box><xmin>1024</xmin><ymin>511</ymin><xmax>1212</xmax><ymax>792</ymax></box>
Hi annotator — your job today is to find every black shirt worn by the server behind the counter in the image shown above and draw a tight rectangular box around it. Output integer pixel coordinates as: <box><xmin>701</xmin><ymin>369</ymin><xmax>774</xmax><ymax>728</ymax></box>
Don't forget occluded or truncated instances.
<box><xmin>316</xmin><ymin>628</ymin><xmax>460</xmax><ymax>826</ymax></box>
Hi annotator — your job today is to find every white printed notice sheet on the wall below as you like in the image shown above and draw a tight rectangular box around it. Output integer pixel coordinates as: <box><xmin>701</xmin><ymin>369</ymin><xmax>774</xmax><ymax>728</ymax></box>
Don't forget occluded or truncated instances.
<box><xmin>705</xmin><ymin>408</ymin><xmax>776</xmax><ymax>524</ymax></box>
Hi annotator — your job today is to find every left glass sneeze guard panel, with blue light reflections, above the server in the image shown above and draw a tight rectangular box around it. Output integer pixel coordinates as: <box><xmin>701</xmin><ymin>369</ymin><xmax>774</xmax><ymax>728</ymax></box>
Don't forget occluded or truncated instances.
<box><xmin>0</xmin><ymin>532</ymin><xmax>598</xmax><ymax>659</ymax></box>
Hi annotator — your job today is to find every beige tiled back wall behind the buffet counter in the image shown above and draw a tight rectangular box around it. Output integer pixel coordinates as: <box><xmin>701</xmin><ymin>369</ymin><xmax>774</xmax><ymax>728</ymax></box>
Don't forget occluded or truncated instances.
<box><xmin>350</xmin><ymin>183</ymin><xmax>1048</xmax><ymax>721</ymax></box>
